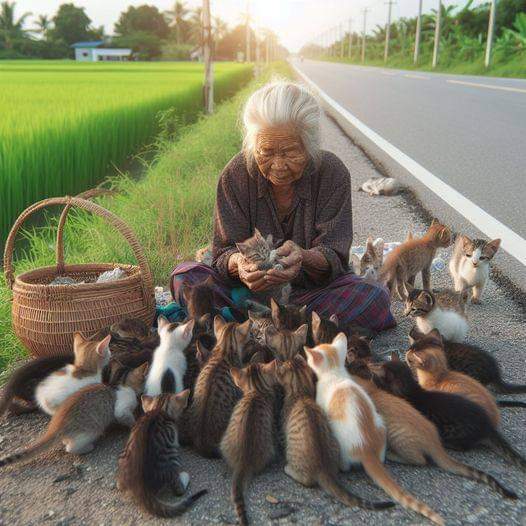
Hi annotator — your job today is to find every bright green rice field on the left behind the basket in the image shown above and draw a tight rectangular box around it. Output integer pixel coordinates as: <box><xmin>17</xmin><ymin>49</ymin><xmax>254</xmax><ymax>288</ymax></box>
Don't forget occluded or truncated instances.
<box><xmin>0</xmin><ymin>61</ymin><xmax>252</xmax><ymax>247</ymax></box>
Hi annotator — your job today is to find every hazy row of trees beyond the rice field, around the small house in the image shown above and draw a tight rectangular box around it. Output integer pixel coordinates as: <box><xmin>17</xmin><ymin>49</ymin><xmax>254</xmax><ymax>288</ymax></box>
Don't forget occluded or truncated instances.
<box><xmin>0</xmin><ymin>1</ymin><xmax>285</xmax><ymax>60</ymax></box>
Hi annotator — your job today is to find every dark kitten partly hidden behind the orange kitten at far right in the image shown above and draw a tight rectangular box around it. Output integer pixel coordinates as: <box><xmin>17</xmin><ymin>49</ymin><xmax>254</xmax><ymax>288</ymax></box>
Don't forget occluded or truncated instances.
<box><xmin>409</xmin><ymin>327</ymin><xmax>526</xmax><ymax>394</ymax></box>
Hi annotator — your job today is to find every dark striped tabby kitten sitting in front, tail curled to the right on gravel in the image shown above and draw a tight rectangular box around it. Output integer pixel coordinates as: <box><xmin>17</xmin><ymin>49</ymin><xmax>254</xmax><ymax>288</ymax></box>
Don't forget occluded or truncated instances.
<box><xmin>117</xmin><ymin>389</ymin><xmax>207</xmax><ymax>518</ymax></box>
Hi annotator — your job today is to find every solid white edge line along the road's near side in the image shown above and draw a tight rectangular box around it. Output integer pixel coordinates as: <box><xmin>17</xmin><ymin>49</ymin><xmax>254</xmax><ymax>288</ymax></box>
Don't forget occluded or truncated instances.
<box><xmin>292</xmin><ymin>64</ymin><xmax>526</xmax><ymax>265</ymax></box>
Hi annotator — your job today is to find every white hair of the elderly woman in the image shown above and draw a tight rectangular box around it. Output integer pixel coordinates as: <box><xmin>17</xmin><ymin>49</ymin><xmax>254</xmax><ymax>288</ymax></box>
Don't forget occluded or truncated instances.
<box><xmin>243</xmin><ymin>80</ymin><xmax>321</xmax><ymax>165</ymax></box>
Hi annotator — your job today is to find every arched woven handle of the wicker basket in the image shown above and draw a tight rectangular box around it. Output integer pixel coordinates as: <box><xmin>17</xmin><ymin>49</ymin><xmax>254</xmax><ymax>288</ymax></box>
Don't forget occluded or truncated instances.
<box><xmin>4</xmin><ymin>197</ymin><xmax>153</xmax><ymax>301</ymax></box>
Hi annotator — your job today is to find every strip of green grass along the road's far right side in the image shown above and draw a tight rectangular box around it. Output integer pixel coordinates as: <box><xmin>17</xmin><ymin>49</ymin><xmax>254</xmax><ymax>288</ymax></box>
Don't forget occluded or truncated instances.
<box><xmin>320</xmin><ymin>50</ymin><xmax>526</xmax><ymax>78</ymax></box>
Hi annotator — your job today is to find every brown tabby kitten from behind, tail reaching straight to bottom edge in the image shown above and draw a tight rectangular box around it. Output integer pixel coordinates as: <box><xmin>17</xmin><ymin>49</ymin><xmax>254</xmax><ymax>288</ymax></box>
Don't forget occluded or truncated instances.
<box><xmin>221</xmin><ymin>362</ymin><xmax>277</xmax><ymax>525</ymax></box>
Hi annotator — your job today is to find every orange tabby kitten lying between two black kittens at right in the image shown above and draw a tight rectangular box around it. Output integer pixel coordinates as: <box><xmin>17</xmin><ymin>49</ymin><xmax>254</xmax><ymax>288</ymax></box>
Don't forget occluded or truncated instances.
<box><xmin>405</xmin><ymin>329</ymin><xmax>500</xmax><ymax>427</ymax></box>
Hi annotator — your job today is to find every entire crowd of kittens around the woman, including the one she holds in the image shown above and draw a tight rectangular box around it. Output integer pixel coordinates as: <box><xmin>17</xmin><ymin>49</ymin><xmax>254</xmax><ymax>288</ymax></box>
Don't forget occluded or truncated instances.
<box><xmin>0</xmin><ymin>221</ymin><xmax>526</xmax><ymax>525</ymax></box>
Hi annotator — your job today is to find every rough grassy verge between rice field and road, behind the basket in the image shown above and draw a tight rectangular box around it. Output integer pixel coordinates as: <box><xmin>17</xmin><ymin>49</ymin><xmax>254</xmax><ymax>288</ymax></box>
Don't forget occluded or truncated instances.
<box><xmin>0</xmin><ymin>63</ymin><xmax>290</xmax><ymax>376</ymax></box>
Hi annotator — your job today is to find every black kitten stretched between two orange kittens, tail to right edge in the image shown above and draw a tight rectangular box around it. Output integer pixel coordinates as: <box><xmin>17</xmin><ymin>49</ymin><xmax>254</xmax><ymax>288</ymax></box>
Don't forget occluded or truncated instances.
<box><xmin>372</xmin><ymin>353</ymin><xmax>526</xmax><ymax>470</ymax></box>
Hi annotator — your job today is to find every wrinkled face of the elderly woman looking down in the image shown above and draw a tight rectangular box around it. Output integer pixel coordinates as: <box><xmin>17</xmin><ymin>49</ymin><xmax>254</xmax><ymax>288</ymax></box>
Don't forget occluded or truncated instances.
<box><xmin>254</xmin><ymin>126</ymin><xmax>308</xmax><ymax>186</ymax></box>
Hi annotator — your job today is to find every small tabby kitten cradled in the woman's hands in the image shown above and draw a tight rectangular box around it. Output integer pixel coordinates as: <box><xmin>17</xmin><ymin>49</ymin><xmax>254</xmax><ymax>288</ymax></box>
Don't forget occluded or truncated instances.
<box><xmin>236</xmin><ymin>228</ymin><xmax>291</xmax><ymax>304</ymax></box>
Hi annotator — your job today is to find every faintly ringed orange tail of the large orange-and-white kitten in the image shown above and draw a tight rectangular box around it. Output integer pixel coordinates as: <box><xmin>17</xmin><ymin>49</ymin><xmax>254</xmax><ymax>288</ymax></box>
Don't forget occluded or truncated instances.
<box><xmin>362</xmin><ymin>453</ymin><xmax>445</xmax><ymax>526</ymax></box>
